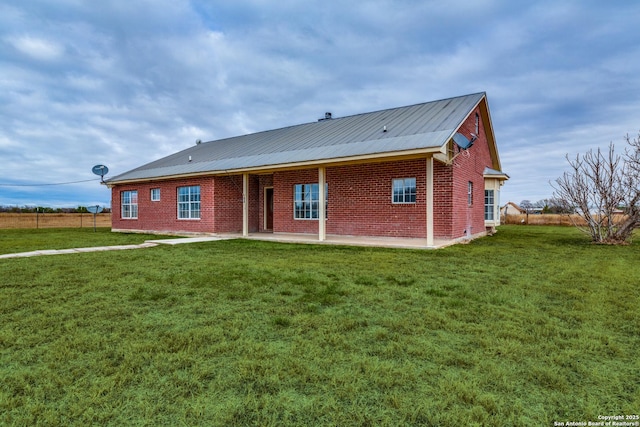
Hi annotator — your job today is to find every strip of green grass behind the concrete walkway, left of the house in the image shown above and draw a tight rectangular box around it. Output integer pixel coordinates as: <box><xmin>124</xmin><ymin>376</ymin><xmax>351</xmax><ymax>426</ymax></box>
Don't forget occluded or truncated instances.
<box><xmin>0</xmin><ymin>227</ymin><xmax>171</xmax><ymax>255</ymax></box>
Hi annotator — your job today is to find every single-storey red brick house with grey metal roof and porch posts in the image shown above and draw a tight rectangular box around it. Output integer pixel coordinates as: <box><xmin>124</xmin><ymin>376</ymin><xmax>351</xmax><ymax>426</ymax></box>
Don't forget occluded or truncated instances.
<box><xmin>106</xmin><ymin>93</ymin><xmax>508</xmax><ymax>246</ymax></box>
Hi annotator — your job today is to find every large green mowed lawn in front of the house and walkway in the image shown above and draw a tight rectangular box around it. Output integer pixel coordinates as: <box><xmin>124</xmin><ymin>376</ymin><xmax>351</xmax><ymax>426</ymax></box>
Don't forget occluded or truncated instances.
<box><xmin>0</xmin><ymin>226</ymin><xmax>640</xmax><ymax>426</ymax></box>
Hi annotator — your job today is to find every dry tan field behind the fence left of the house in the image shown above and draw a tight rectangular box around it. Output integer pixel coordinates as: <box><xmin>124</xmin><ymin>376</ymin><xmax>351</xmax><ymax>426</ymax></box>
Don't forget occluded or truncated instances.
<box><xmin>0</xmin><ymin>212</ymin><xmax>111</xmax><ymax>229</ymax></box>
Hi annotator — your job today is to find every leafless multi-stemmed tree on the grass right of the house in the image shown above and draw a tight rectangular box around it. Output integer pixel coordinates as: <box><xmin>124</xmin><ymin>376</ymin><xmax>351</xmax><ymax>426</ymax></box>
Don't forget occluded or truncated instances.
<box><xmin>552</xmin><ymin>135</ymin><xmax>640</xmax><ymax>244</ymax></box>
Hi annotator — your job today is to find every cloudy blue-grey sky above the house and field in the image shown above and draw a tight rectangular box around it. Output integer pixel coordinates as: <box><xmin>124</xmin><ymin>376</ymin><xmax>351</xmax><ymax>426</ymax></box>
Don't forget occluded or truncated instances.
<box><xmin>0</xmin><ymin>0</ymin><xmax>640</xmax><ymax>207</ymax></box>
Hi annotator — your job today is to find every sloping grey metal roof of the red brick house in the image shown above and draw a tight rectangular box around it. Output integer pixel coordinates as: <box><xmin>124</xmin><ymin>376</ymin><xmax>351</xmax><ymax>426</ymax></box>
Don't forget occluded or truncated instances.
<box><xmin>105</xmin><ymin>92</ymin><xmax>486</xmax><ymax>184</ymax></box>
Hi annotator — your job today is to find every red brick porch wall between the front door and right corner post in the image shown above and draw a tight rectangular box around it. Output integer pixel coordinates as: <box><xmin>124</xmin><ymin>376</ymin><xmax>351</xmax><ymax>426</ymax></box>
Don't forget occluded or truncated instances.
<box><xmin>273</xmin><ymin>160</ymin><xmax>426</xmax><ymax>237</ymax></box>
